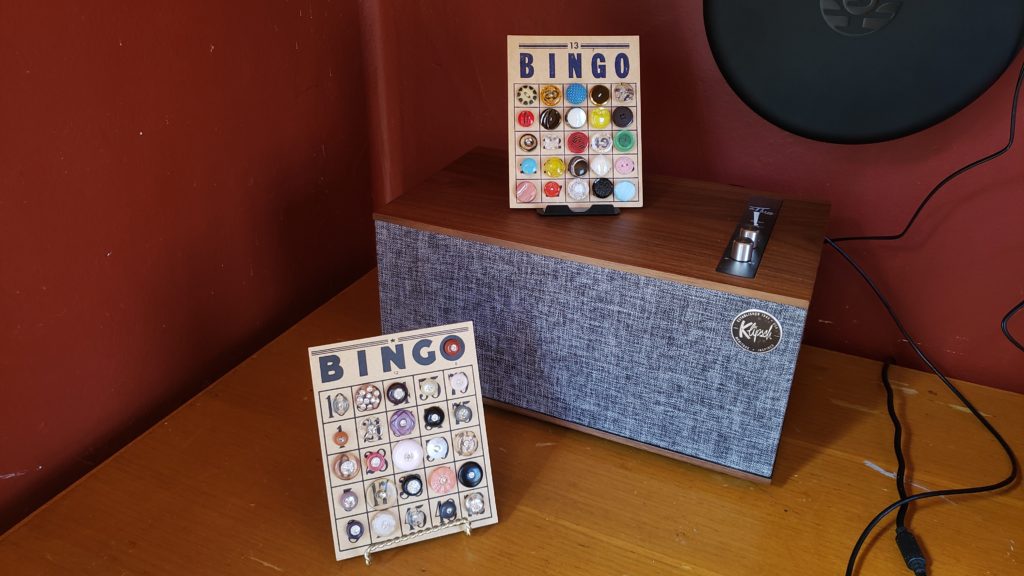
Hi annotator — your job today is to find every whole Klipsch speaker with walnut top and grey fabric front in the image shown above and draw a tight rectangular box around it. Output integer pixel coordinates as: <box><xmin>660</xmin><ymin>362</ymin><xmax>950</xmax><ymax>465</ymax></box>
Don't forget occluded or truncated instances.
<box><xmin>375</xmin><ymin>150</ymin><xmax>828</xmax><ymax>480</ymax></box>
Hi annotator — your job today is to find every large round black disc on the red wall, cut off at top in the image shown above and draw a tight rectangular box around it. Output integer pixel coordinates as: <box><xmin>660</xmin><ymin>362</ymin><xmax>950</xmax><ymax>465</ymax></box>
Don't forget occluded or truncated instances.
<box><xmin>703</xmin><ymin>0</ymin><xmax>1024</xmax><ymax>143</ymax></box>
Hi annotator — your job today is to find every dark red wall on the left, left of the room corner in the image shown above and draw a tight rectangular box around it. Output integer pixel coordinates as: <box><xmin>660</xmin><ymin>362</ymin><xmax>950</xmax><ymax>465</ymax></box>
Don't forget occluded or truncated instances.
<box><xmin>0</xmin><ymin>0</ymin><xmax>374</xmax><ymax>532</ymax></box>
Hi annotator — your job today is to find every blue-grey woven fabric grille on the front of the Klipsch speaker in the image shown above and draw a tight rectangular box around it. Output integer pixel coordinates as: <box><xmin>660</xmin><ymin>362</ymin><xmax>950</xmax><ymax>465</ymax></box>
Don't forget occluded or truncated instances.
<box><xmin>377</xmin><ymin>221</ymin><xmax>806</xmax><ymax>478</ymax></box>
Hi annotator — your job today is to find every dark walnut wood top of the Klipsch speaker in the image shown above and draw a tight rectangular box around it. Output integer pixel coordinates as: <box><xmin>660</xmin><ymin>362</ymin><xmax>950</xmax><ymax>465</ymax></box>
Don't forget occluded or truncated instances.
<box><xmin>374</xmin><ymin>149</ymin><xmax>828</xmax><ymax>308</ymax></box>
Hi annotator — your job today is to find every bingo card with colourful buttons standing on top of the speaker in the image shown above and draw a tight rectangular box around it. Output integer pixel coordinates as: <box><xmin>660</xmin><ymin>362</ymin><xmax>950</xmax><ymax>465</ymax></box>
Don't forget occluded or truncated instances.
<box><xmin>508</xmin><ymin>36</ymin><xmax>643</xmax><ymax>208</ymax></box>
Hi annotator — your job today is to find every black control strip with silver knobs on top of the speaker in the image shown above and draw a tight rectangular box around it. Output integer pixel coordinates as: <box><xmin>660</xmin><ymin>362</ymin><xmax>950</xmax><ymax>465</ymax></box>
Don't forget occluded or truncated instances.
<box><xmin>715</xmin><ymin>197</ymin><xmax>782</xmax><ymax>278</ymax></box>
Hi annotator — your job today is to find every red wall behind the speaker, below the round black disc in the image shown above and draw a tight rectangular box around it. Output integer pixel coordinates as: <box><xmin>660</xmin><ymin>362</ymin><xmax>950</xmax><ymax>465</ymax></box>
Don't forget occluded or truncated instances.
<box><xmin>364</xmin><ymin>0</ymin><xmax>1024</xmax><ymax>392</ymax></box>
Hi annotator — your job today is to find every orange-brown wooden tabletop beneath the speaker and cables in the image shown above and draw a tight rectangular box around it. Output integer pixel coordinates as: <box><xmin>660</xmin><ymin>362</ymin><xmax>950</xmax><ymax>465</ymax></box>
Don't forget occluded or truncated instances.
<box><xmin>0</xmin><ymin>274</ymin><xmax>1024</xmax><ymax>576</ymax></box>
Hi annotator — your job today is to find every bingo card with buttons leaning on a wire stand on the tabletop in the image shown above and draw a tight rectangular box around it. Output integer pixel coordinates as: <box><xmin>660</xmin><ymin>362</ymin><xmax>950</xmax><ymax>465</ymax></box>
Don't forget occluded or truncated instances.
<box><xmin>309</xmin><ymin>322</ymin><xmax>498</xmax><ymax>560</ymax></box>
